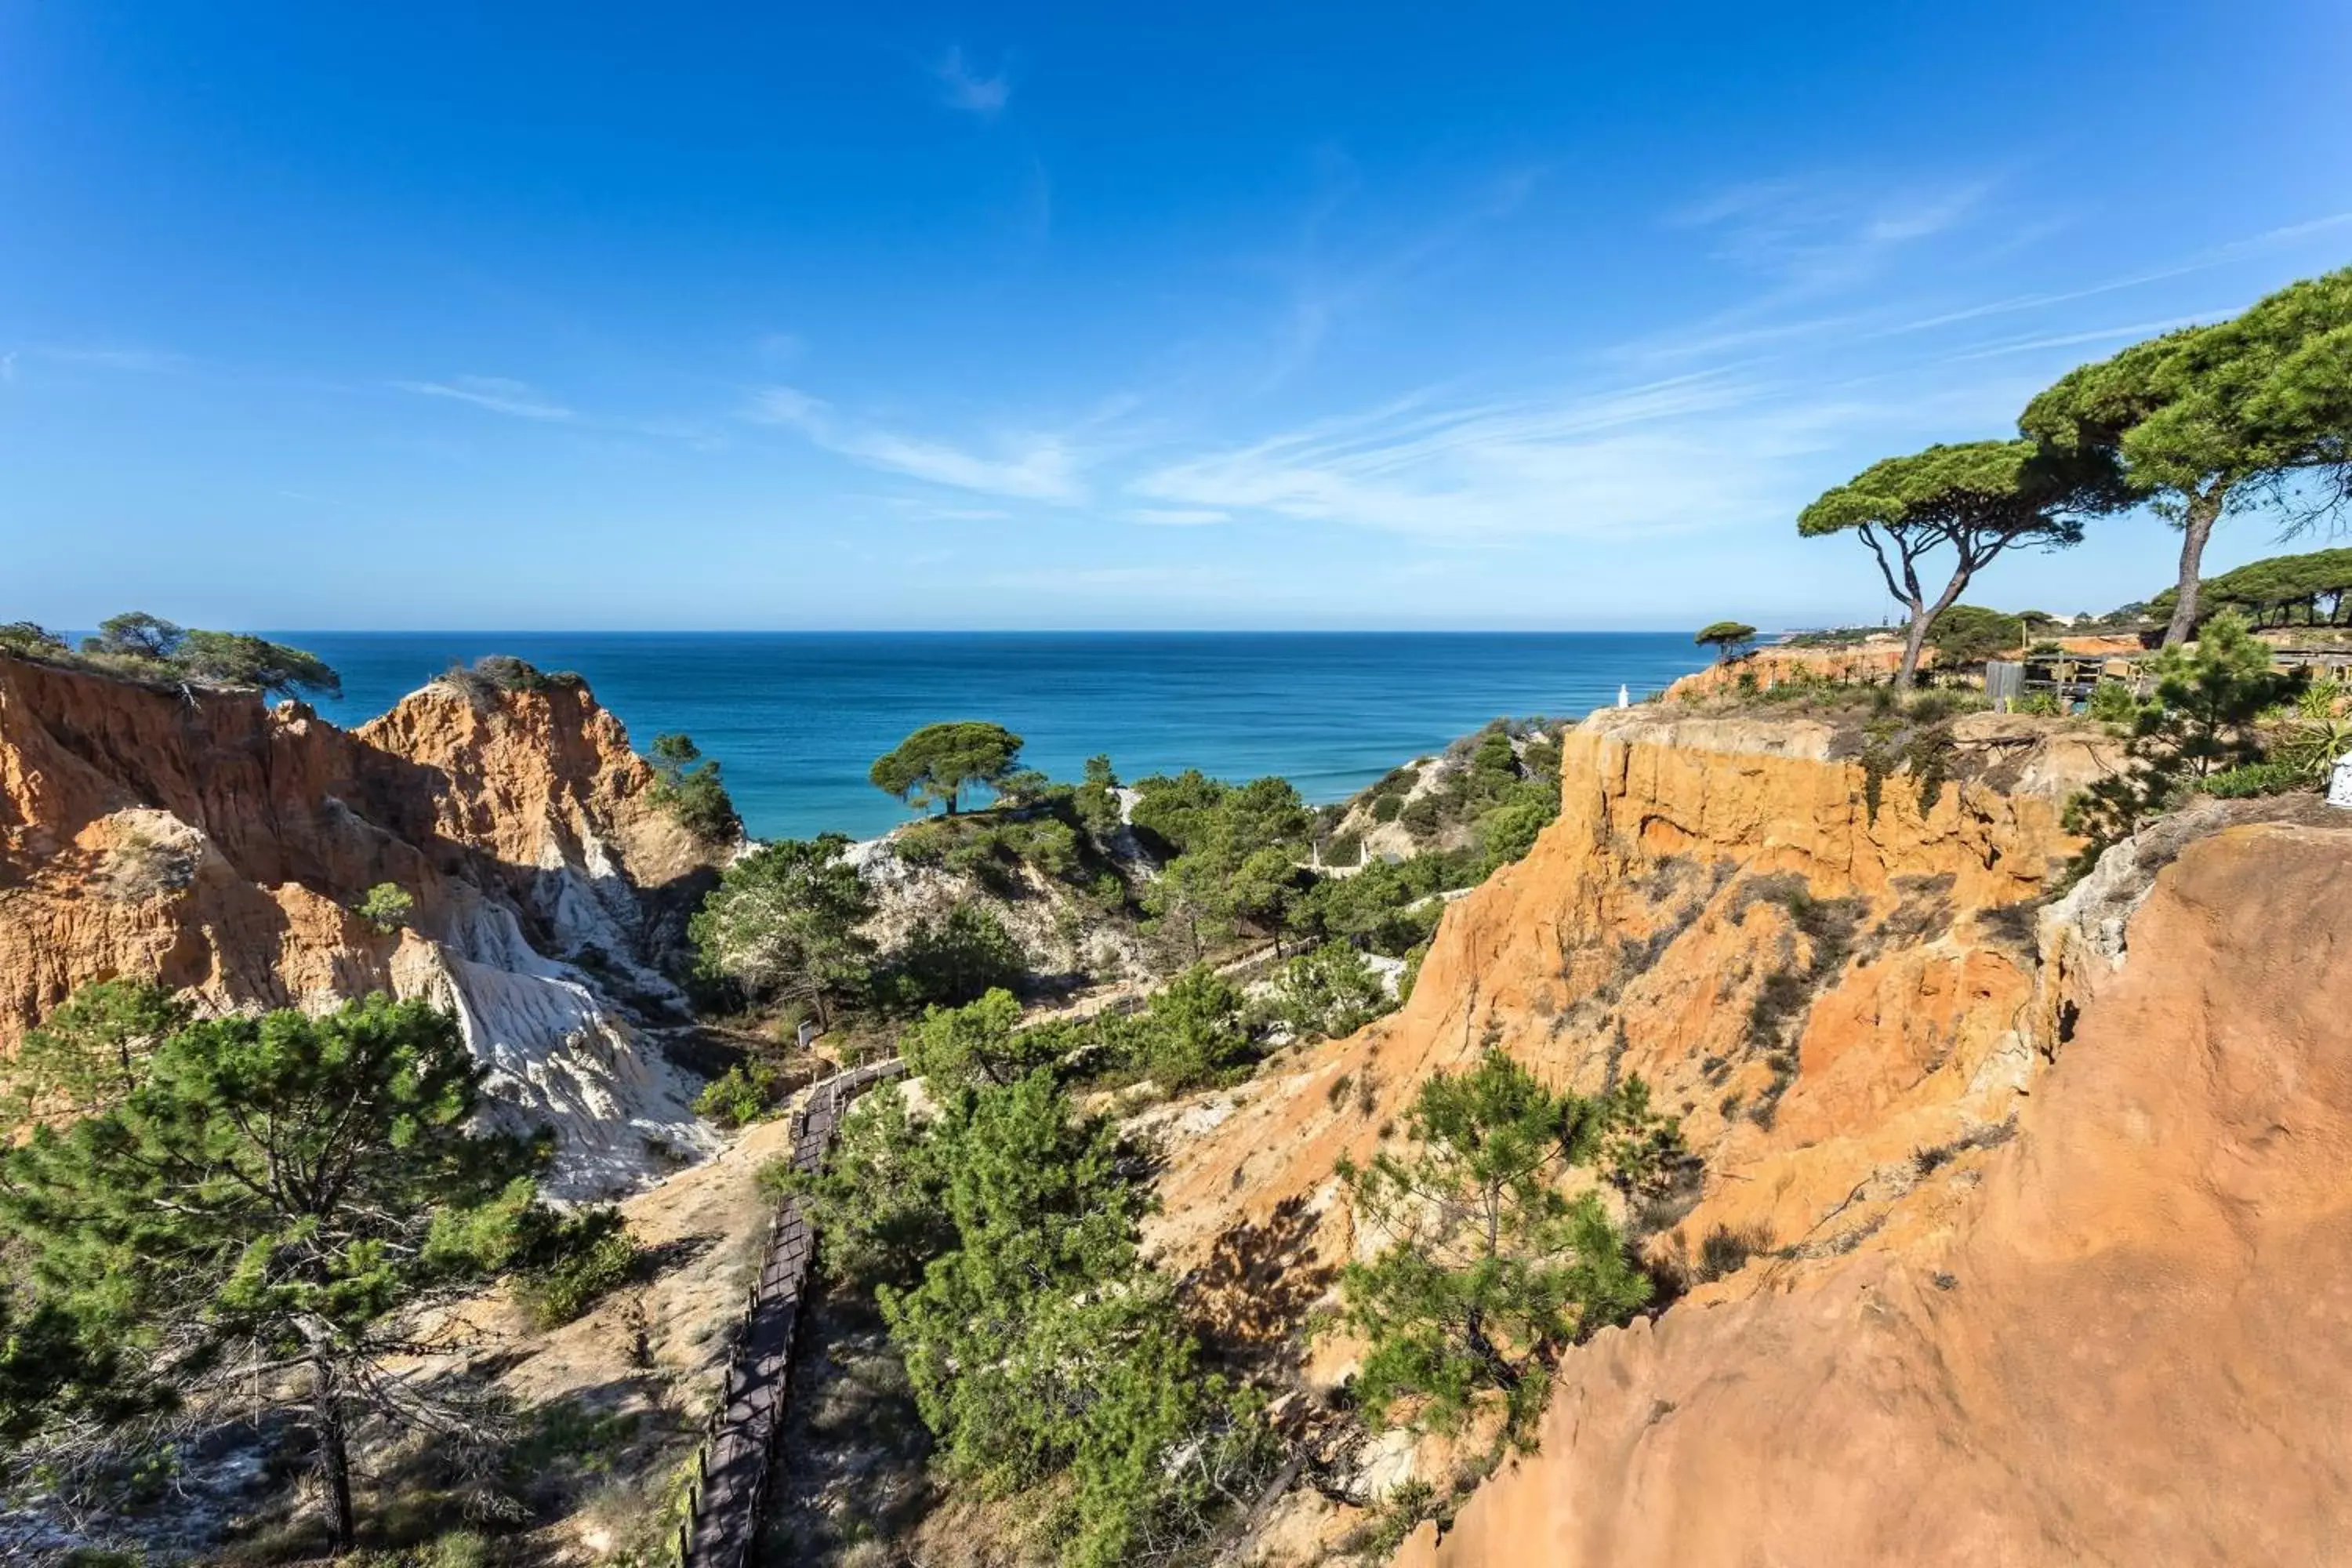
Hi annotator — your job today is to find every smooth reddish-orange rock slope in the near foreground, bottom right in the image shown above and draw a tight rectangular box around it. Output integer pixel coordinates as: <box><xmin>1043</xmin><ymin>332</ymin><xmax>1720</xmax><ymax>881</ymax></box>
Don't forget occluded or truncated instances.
<box><xmin>1397</xmin><ymin>820</ymin><xmax>2352</xmax><ymax>1568</ymax></box>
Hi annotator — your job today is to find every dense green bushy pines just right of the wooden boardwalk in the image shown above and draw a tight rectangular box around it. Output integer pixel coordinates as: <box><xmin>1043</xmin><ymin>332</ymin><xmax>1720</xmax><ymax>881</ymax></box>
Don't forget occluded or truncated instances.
<box><xmin>769</xmin><ymin>1062</ymin><xmax>1275</xmax><ymax>1568</ymax></box>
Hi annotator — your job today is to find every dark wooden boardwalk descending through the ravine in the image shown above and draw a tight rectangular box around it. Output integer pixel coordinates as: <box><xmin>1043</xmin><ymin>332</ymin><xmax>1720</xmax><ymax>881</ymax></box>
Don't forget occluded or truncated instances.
<box><xmin>675</xmin><ymin>1060</ymin><xmax>906</xmax><ymax>1568</ymax></box>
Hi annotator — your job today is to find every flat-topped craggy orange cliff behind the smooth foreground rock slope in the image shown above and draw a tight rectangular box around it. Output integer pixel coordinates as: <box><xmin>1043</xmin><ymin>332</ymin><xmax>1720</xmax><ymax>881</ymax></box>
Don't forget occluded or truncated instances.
<box><xmin>1160</xmin><ymin>706</ymin><xmax>2107</xmax><ymax>1298</ymax></box>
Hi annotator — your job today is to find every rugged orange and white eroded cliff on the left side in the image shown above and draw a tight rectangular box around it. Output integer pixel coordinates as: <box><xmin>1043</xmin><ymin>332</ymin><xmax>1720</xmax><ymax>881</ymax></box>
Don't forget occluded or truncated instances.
<box><xmin>0</xmin><ymin>659</ymin><xmax>710</xmax><ymax>1192</ymax></box>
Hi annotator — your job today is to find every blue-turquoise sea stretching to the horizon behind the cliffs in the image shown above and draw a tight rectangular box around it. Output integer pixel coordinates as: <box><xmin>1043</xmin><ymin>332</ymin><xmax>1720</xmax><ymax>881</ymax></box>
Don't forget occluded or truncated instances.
<box><xmin>289</xmin><ymin>633</ymin><xmax>1705</xmax><ymax>837</ymax></box>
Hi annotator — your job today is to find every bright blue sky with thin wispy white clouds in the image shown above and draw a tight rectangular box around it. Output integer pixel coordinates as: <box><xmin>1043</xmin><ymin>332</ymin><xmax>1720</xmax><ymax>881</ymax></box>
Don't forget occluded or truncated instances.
<box><xmin>0</xmin><ymin>0</ymin><xmax>2352</xmax><ymax>628</ymax></box>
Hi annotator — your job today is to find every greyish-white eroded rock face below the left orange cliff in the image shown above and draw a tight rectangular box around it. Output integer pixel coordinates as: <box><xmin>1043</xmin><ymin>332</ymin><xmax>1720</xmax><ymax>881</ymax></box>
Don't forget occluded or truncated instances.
<box><xmin>393</xmin><ymin>900</ymin><xmax>722</xmax><ymax>1199</ymax></box>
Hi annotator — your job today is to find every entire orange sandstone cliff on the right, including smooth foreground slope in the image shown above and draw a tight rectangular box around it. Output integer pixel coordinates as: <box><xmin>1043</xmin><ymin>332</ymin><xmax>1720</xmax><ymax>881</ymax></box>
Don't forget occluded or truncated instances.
<box><xmin>1155</xmin><ymin>708</ymin><xmax>2352</xmax><ymax>1568</ymax></box>
